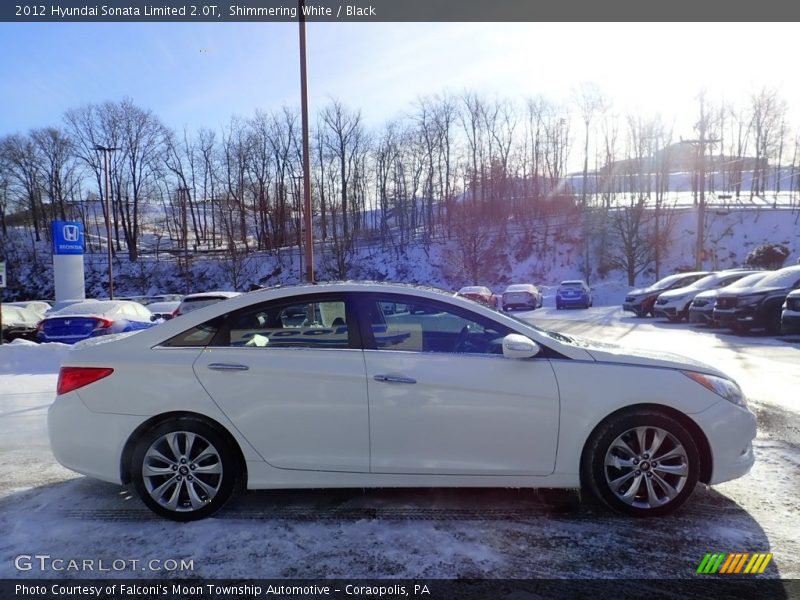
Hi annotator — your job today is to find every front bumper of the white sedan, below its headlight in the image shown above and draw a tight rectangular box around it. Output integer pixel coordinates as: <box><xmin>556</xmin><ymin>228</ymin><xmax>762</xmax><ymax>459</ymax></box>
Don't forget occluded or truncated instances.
<box><xmin>692</xmin><ymin>400</ymin><xmax>757</xmax><ymax>484</ymax></box>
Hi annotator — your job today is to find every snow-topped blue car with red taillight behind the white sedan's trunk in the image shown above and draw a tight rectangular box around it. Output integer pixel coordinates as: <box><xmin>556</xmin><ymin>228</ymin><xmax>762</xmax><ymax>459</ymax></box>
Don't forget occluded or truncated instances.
<box><xmin>37</xmin><ymin>300</ymin><xmax>154</xmax><ymax>344</ymax></box>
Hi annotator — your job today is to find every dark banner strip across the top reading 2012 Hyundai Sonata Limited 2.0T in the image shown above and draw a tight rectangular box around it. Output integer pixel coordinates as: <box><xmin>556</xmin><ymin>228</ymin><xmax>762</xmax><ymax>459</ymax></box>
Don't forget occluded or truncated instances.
<box><xmin>0</xmin><ymin>0</ymin><xmax>800</xmax><ymax>23</ymax></box>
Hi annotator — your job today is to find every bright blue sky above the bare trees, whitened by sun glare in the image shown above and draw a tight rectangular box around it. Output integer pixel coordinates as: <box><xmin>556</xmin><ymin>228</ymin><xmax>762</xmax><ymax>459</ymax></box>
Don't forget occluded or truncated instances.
<box><xmin>0</xmin><ymin>23</ymin><xmax>800</xmax><ymax>135</ymax></box>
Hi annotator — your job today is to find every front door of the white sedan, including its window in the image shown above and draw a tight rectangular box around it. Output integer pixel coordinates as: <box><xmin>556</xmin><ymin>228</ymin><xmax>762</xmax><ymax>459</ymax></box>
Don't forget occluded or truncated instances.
<box><xmin>359</xmin><ymin>295</ymin><xmax>559</xmax><ymax>475</ymax></box>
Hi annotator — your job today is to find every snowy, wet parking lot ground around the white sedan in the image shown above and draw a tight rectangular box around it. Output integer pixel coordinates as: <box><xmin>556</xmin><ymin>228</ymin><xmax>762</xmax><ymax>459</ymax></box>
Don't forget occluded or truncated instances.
<box><xmin>0</xmin><ymin>307</ymin><xmax>800</xmax><ymax>579</ymax></box>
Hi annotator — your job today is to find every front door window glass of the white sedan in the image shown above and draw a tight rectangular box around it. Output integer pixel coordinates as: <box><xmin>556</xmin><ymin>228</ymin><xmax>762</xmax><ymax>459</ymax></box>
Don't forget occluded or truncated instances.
<box><xmin>362</xmin><ymin>297</ymin><xmax>511</xmax><ymax>354</ymax></box>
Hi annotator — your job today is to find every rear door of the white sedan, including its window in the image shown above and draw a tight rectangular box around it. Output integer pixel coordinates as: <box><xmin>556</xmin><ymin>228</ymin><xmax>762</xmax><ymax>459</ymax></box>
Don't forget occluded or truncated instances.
<box><xmin>194</xmin><ymin>294</ymin><xmax>369</xmax><ymax>472</ymax></box>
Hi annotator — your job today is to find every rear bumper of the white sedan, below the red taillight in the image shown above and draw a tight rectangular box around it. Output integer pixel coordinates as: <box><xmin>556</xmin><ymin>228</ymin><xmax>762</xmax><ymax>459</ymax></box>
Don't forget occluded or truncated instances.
<box><xmin>47</xmin><ymin>392</ymin><xmax>146</xmax><ymax>483</ymax></box>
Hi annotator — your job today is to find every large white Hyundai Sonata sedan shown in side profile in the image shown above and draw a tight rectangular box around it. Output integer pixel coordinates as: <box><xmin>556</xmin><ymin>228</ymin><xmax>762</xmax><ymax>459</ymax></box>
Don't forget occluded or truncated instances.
<box><xmin>49</xmin><ymin>283</ymin><xmax>756</xmax><ymax>521</ymax></box>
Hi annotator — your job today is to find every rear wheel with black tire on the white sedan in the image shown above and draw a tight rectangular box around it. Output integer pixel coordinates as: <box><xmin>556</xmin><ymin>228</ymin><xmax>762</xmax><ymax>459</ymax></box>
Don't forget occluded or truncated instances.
<box><xmin>131</xmin><ymin>417</ymin><xmax>241</xmax><ymax>521</ymax></box>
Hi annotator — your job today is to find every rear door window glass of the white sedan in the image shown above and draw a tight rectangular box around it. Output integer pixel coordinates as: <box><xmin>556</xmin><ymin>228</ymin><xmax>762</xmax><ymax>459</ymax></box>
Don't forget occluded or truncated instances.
<box><xmin>212</xmin><ymin>299</ymin><xmax>349</xmax><ymax>349</ymax></box>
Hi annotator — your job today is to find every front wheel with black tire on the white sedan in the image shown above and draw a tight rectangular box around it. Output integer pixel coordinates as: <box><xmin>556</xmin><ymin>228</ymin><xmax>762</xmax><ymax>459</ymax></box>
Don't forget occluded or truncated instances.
<box><xmin>581</xmin><ymin>409</ymin><xmax>700</xmax><ymax>517</ymax></box>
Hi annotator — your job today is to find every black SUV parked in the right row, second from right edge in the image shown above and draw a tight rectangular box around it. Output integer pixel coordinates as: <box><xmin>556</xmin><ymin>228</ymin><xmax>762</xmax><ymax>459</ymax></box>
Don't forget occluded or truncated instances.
<box><xmin>714</xmin><ymin>265</ymin><xmax>800</xmax><ymax>335</ymax></box>
